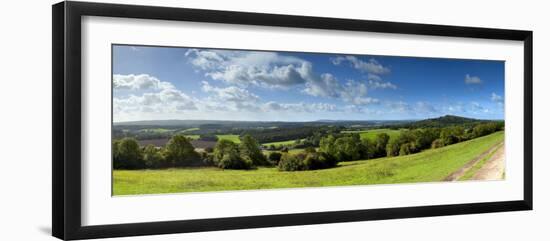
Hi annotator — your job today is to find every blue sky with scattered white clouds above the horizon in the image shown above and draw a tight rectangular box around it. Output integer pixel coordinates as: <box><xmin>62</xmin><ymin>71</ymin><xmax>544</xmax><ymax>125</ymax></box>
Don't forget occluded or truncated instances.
<box><xmin>113</xmin><ymin>45</ymin><xmax>504</xmax><ymax>122</ymax></box>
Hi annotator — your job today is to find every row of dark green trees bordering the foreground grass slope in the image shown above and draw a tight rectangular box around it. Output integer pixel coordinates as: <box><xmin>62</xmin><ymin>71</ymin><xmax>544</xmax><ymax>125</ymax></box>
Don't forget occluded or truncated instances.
<box><xmin>112</xmin><ymin>122</ymin><xmax>504</xmax><ymax>171</ymax></box>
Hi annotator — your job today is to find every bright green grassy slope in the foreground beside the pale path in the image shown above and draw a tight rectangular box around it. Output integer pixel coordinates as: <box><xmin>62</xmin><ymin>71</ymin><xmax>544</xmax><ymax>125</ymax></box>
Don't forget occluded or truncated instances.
<box><xmin>113</xmin><ymin>131</ymin><xmax>504</xmax><ymax>195</ymax></box>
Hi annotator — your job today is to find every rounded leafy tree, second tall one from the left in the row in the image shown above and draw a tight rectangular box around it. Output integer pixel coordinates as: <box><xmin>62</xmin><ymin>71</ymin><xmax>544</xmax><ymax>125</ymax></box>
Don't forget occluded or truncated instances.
<box><xmin>165</xmin><ymin>134</ymin><xmax>202</xmax><ymax>167</ymax></box>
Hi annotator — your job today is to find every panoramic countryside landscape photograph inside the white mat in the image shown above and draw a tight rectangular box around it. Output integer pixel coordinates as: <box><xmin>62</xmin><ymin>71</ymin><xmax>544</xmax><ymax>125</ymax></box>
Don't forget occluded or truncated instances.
<box><xmin>111</xmin><ymin>44</ymin><xmax>506</xmax><ymax>196</ymax></box>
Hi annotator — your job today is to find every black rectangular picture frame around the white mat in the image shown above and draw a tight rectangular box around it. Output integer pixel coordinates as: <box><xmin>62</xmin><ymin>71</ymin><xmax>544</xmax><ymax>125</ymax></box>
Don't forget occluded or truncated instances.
<box><xmin>52</xmin><ymin>2</ymin><xmax>533</xmax><ymax>240</ymax></box>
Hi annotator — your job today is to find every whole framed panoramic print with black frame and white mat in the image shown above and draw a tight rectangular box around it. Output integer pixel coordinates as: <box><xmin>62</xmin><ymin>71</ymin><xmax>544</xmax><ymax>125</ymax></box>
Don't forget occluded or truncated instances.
<box><xmin>52</xmin><ymin>1</ymin><xmax>532</xmax><ymax>239</ymax></box>
